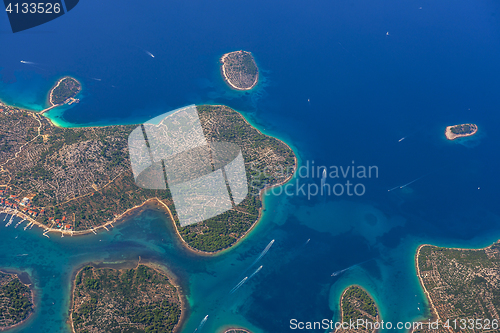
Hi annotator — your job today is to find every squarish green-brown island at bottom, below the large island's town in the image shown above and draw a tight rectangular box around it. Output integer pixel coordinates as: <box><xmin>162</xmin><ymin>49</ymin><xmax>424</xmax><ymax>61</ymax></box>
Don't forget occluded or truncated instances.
<box><xmin>71</xmin><ymin>265</ymin><xmax>183</xmax><ymax>333</ymax></box>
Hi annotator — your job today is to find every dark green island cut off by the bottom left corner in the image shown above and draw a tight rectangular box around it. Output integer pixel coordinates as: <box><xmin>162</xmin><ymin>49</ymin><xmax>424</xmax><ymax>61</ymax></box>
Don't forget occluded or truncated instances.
<box><xmin>0</xmin><ymin>272</ymin><xmax>33</xmax><ymax>331</ymax></box>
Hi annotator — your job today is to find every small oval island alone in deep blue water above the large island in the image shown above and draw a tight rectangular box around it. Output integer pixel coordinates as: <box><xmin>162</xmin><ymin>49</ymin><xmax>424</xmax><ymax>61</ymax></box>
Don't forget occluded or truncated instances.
<box><xmin>220</xmin><ymin>51</ymin><xmax>259</xmax><ymax>90</ymax></box>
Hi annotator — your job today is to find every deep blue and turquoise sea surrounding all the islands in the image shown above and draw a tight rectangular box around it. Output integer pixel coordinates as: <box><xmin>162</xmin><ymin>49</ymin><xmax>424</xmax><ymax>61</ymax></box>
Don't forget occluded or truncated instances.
<box><xmin>0</xmin><ymin>0</ymin><xmax>500</xmax><ymax>333</ymax></box>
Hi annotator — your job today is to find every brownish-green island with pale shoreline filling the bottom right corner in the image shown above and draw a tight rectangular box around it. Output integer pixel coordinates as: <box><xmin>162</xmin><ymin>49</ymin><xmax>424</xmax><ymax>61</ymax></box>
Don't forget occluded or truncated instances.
<box><xmin>415</xmin><ymin>242</ymin><xmax>500</xmax><ymax>332</ymax></box>
